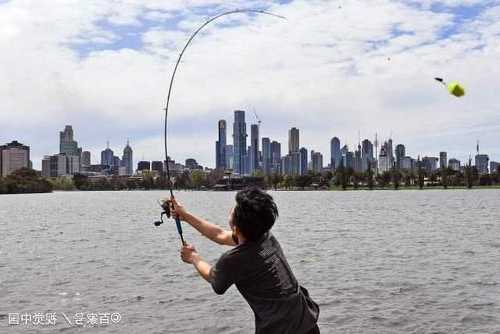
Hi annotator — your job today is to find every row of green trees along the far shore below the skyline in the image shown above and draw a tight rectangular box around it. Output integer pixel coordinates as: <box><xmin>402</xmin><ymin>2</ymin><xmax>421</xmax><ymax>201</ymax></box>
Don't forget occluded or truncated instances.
<box><xmin>0</xmin><ymin>165</ymin><xmax>500</xmax><ymax>194</ymax></box>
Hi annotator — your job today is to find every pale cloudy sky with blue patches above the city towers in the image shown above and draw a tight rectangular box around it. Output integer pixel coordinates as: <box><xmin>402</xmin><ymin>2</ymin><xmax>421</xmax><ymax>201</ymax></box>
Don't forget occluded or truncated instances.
<box><xmin>0</xmin><ymin>0</ymin><xmax>500</xmax><ymax>168</ymax></box>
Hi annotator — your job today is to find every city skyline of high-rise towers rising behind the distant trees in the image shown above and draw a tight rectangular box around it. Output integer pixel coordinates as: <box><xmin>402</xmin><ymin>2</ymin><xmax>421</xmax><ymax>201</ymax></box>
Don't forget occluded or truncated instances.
<box><xmin>1</xmin><ymin>118</ymin><xmax>498</xmax><ymax>176</ymax></box>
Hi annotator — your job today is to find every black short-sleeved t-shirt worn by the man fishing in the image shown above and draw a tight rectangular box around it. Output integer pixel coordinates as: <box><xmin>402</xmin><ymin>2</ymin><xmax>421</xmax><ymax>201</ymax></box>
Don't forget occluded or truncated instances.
<box><xmin>210</xmin><ymin>232</ymin><xmax>319</xmax><ymax>334</ymax></box>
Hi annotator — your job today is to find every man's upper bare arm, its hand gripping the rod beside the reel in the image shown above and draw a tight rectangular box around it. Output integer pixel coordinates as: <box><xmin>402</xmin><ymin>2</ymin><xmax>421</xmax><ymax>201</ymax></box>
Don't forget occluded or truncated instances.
<box><xmin>171</xmin><ymin>198</ymin><xmax>236</xmax><ymax>246</ymax></box>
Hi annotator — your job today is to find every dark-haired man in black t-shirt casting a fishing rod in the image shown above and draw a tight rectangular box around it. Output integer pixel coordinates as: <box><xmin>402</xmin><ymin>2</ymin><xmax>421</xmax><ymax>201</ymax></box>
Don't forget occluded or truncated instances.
<box><xmin>171</xmin><ymin>188</ymin><xmax>319</xmax><ymax>334</ymax></box>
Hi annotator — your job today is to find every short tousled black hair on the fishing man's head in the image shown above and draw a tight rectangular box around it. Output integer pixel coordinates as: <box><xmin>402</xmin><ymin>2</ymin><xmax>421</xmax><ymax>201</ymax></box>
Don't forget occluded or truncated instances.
<box><xmin>234</xmin><ymin>187</ymin><xmax>278</xmax><ymax>241</ymax></box>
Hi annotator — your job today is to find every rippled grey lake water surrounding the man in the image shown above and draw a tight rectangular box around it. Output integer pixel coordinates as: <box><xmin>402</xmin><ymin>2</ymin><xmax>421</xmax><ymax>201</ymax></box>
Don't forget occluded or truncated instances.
<box><xmin>0</xmin><ymin>190</ymin><xmax>500</xmax><ymax>334</ymax></box>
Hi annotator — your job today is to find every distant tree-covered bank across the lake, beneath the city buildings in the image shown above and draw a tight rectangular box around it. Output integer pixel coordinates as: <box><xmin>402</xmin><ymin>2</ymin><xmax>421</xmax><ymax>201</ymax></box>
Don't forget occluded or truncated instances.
<box><xmin>0</xmin><ymin>168</ymin><xmax>500</xmax><ymax>194</ymax></box>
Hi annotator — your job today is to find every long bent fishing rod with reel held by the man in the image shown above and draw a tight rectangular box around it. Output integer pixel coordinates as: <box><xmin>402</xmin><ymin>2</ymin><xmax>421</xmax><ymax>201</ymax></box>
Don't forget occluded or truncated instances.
<box><xmin>154</xmin><ymin>9</ymin><xmax>286</xmax><ymax>245</ymax></box>
